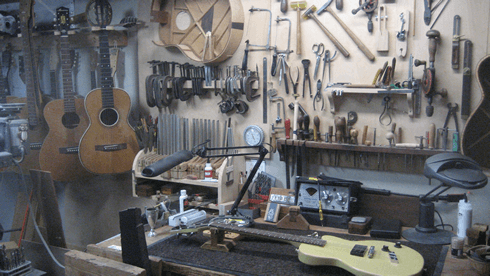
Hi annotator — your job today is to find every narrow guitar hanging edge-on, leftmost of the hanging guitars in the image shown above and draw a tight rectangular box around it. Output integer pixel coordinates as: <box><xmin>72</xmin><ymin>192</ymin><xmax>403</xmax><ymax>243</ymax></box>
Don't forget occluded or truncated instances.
<box><xmin>11</xmin><ymin>0</ymin><xmax>48</xmax><ymax>170</ymax></box>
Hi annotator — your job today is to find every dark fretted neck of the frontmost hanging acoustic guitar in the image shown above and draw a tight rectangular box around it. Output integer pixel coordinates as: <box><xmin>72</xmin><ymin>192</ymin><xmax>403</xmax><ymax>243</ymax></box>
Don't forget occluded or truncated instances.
<box><xmin>99</xmin><ymin>30</ymin><xmax>114</xmax><ymax>108</ymax></box>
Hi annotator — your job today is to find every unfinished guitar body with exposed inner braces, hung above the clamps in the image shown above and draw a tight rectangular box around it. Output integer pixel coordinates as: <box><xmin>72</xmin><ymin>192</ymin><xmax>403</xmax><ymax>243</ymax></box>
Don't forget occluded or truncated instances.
<box><xmin>151</xmin><ymin>0</ymin><xmax>245</xmax><ymax>63</ymax></box>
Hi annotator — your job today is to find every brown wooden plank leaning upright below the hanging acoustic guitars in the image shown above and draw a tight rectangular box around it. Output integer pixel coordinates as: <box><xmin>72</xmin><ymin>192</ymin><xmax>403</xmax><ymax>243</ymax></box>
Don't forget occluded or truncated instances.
<box><xmin>29</xmin><ymin>170</ymin><xmax>66</xmax><ymax>248</ymax></box>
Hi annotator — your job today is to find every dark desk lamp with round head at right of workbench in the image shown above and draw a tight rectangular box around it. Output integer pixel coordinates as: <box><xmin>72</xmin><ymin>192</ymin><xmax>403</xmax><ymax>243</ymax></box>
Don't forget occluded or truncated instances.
<box><xmin>402</xmin><ymin>152</ymin><xmax>488</xmax><ymax>244</ymax></box>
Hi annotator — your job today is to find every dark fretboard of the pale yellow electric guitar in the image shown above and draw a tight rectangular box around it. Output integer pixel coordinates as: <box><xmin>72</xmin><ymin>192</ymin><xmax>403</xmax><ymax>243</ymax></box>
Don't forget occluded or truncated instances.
<box><xmin>209</xmin><ymin>223</ymin><xmax>327</xmax><ymax>246</ymax></box>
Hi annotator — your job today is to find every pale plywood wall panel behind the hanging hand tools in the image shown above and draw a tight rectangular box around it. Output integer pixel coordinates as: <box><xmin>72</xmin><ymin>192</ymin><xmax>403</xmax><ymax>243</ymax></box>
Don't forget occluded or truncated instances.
<box><xmin>138</xmin><ymin>0</ymin><xmax>490</xmax><ymax>167</ymax></box>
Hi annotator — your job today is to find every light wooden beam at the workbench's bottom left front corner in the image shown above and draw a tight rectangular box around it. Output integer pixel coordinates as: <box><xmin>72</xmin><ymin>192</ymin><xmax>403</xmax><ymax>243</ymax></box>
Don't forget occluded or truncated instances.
<box><xmin>65</xmin><ymin>250</ymin><xmax>146</xmax><ymax>276</ymax></box>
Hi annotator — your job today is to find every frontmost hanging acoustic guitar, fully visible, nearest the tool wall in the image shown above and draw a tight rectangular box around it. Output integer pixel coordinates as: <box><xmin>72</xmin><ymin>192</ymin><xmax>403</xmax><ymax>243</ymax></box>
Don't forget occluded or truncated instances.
<box><xmin>79</xmin><ymin>0</ymin><xmax>139</xmax><ymax>174</ymax></box>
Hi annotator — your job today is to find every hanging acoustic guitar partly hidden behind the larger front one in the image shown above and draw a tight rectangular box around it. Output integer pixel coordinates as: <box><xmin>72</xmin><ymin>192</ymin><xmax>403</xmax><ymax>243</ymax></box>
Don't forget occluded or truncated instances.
<box><xmin>39</xmin><ymin>7</ymin><xmax>91</xmax><ymax>181</ymax></box>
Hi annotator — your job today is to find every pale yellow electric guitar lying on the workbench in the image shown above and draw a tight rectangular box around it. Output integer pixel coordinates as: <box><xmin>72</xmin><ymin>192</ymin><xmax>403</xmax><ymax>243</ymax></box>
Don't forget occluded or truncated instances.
<box><xmin>176</xmin><ymin>222</ymin><xmax>424</xmax><ymax>275</ymax></box>
